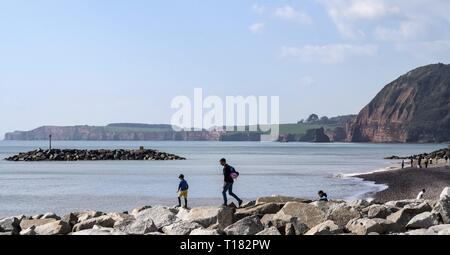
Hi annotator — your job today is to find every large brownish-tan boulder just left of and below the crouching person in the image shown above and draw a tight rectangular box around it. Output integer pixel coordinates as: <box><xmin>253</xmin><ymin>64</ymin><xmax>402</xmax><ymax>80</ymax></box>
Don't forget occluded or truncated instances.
<box><xmin>273</xmin><ymin>202</ymin><xmax>326</xmax><ymax>228</ymax></box>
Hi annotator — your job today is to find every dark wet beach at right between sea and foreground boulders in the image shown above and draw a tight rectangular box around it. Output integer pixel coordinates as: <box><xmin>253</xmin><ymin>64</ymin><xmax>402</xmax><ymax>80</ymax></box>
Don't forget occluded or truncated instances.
<box><xmin>356</xmin><ymin>165</ymin><xmax>450</xmax><ymax>203</ymax></box>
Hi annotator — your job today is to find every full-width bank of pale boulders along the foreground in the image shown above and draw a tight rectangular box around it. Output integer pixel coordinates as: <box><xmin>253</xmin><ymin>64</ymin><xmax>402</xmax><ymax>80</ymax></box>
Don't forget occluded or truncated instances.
<box><xmin>0</xmin><ymin>187</ymin><xmax>450</xmax><ymax>235</ymax></box>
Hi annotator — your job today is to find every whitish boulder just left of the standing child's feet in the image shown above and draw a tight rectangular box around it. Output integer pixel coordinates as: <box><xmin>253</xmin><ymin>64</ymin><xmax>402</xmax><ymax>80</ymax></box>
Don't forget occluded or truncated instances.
<box><xmin>136</xmin><ymin>206</ymin><xmax>177</xmax><ymax>229</ymax></box>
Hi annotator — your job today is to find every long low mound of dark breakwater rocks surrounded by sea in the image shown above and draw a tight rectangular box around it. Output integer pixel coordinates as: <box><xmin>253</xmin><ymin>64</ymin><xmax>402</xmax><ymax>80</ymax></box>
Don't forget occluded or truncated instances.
<box><xmin>6</xmin><ymin>148</ymin><xmax>185</xmax><ymax>161</ymax></box>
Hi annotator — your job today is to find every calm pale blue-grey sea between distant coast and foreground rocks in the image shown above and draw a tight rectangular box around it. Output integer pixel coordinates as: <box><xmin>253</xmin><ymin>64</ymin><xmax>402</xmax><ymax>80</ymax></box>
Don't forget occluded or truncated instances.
<box><xmin>0</xmin><ymin>141</ymin><xmax>445</xmax><ymax>217</ymax></box>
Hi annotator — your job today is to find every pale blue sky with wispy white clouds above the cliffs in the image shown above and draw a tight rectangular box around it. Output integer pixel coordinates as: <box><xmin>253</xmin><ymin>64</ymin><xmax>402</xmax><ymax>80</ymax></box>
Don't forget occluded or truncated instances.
<box><xmin>0</xmin><ymin>0</ymin><xmax>450</xmax><ymax>134</ymax></box>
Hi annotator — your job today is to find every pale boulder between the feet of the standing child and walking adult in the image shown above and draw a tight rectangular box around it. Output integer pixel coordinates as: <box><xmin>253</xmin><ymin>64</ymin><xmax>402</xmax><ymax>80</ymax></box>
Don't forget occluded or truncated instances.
<box><xmin>177</xmin><ymin>207</ymin><xmax>233</xmax><ymax>230</ymax></box>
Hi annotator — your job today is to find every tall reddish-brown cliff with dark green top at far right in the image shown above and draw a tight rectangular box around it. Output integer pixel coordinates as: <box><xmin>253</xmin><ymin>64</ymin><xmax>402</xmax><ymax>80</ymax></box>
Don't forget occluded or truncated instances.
<box><xmin>347</xmin><ymin>64</ymin><xmax>450</xmax><ymax>142</ymax></box>
